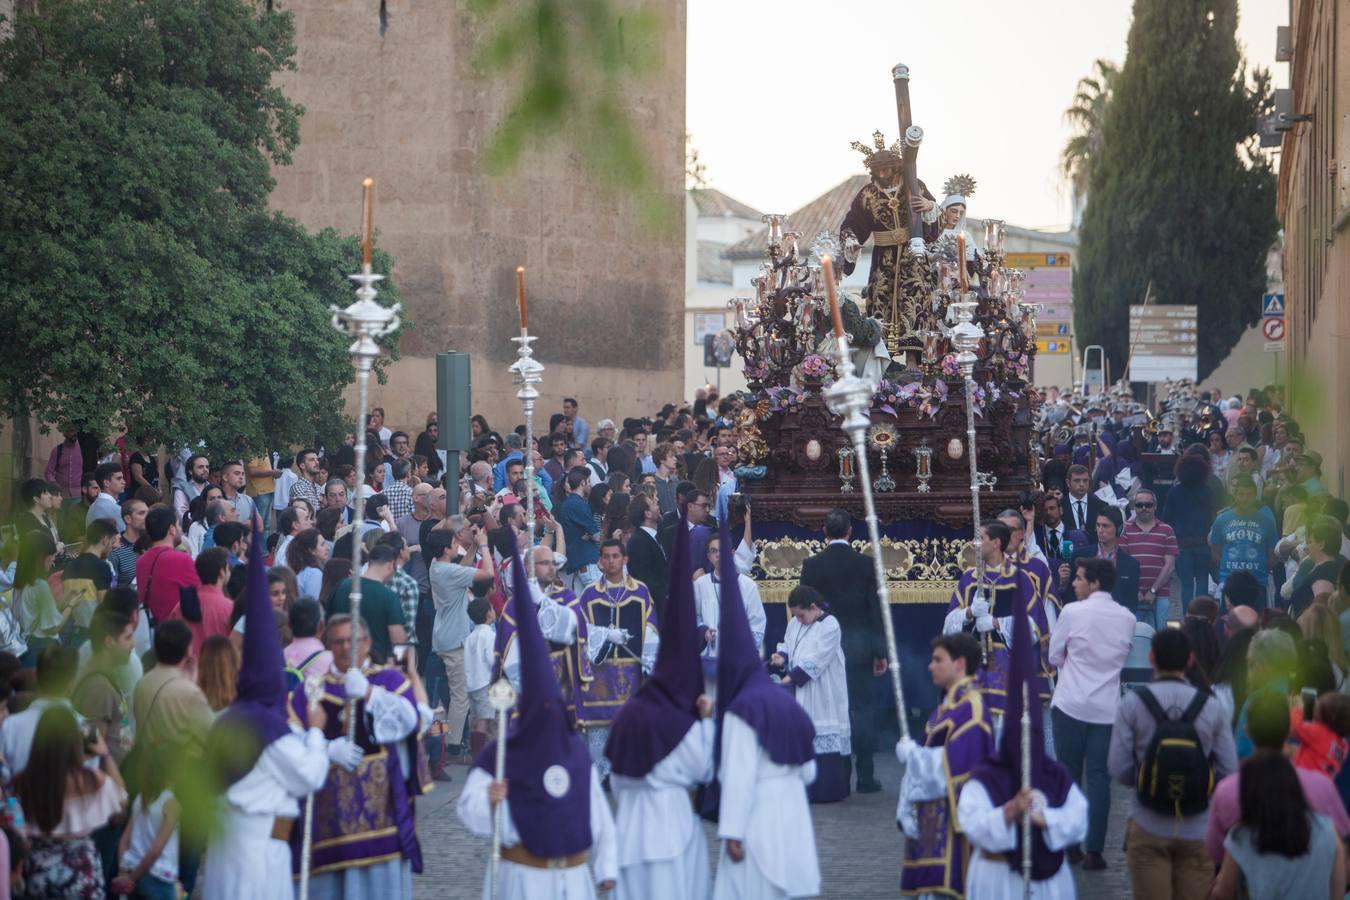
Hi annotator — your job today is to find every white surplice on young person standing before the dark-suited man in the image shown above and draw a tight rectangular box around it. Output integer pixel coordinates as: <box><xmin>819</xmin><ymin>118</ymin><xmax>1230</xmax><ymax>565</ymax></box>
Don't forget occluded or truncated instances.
<box><xmin>778</xmin><ymin>615</ymin><xmax>852</xmax><ymax>756</ymax></box>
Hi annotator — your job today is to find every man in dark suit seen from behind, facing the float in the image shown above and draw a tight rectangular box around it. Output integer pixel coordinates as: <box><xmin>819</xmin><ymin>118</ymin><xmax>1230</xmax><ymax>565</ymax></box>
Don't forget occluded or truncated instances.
<box><xmin>802</xmin><ymin>509</ymin><xmax>886</xmax><ymax>793</ymax></box>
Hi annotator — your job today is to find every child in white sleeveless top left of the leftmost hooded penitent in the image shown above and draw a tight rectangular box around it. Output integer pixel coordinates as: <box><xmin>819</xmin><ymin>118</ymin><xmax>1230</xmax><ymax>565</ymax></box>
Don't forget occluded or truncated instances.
<box><xmin>111</xmin><ymin>752</ymin><xmax>178</xmax><ymax>900</ymax></box>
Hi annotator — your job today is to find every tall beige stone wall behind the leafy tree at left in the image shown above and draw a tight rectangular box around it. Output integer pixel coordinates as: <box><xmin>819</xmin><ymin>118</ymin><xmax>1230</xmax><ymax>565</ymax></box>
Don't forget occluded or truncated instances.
<box><xmin>271</xmin><ymin>0</ymin><xmax>686</xmax><ymax>432</ymax></box>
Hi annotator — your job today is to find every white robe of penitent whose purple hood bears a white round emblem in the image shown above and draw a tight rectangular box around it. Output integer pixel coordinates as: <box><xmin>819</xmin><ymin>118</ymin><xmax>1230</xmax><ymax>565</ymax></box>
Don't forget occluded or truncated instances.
<box><xmin>455</xmin><ymin>766</ymin><xmax>618</xmax><ymax>900</ymax></box>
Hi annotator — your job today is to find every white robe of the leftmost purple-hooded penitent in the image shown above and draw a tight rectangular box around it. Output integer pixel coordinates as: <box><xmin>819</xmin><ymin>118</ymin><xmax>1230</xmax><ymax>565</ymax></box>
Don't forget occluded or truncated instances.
<box><xmin>201</xmin><ymin>729</ymin><xmax>328</xmax><ymax>900</ymax></box>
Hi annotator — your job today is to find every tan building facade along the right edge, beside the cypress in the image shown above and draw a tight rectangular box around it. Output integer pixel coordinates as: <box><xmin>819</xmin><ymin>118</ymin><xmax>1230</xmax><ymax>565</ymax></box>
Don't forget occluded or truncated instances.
<box><xmin>1277</xmin><ymin>0</ymin><xmax>1350</xmax><ymax>497</ymax></box>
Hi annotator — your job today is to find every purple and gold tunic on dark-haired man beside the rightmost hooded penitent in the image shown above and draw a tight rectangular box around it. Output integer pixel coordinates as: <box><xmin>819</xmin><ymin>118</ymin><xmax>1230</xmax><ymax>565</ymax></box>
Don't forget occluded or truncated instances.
<box><xmin>900</xmin><ymin>676</ymin><xmax>994</xmax><ymax>897</ymax></box>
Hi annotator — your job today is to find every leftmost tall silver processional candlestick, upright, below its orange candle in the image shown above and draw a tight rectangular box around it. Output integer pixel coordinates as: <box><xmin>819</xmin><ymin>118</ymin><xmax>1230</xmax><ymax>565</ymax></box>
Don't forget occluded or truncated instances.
<box><xmin>329</xmin><ymin>260</ymin><xmax>402</xmax><ymax>741</ymax></box>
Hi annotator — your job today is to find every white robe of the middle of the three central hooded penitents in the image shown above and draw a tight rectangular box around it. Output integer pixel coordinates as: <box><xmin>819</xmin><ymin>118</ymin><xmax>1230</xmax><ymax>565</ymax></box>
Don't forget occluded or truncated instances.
<box><xmin>610</xmin><ymin>719</ymin><xmax>717</xmax><ymax>900</ymax></box>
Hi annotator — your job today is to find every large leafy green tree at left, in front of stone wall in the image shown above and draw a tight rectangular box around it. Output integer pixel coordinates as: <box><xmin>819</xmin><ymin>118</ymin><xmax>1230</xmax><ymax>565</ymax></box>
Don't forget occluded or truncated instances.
<box><xmin>0</xmin><ymin>0</ymin><xmax>397</xmax><ymax>452</ymax></box>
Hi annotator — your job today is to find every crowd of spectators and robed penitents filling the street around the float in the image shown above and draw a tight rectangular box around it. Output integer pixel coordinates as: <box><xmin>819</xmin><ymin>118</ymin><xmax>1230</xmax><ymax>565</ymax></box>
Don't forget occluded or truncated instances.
<box><xmin>0</xmin><ymin>390</ymin><xmax>1350</xmax><ymax>900</ymax></box>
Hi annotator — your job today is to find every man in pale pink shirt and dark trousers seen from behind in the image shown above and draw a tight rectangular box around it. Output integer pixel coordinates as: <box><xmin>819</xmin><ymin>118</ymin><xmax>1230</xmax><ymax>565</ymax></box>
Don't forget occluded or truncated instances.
<box><xmin>1050</xmin><ymin>557</ymin><xmax>1134</xmax><ymax>869</ymax></box>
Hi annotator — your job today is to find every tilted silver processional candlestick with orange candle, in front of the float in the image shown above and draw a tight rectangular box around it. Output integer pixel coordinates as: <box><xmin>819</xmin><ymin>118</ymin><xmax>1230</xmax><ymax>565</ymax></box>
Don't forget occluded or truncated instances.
<box><xmin>821</xmin><ymin>256</ymin><xmax>910</xmax><ymax>738</ymax></box>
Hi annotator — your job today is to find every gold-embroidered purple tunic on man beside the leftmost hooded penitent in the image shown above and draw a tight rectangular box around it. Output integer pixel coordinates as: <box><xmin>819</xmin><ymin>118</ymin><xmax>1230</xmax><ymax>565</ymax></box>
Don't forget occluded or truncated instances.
<box><xmin>289</xmin><ymin>667</ymin><xmax>432</xmax><ymax>876</ymax></box>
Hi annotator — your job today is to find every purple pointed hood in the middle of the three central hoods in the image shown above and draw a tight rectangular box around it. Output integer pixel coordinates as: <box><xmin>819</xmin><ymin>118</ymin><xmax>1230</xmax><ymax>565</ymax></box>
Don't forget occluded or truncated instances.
<box><xmin>605</xmin><ymin>514</ymin><xmax>703</xmax><ymax>779</ymax></box>
